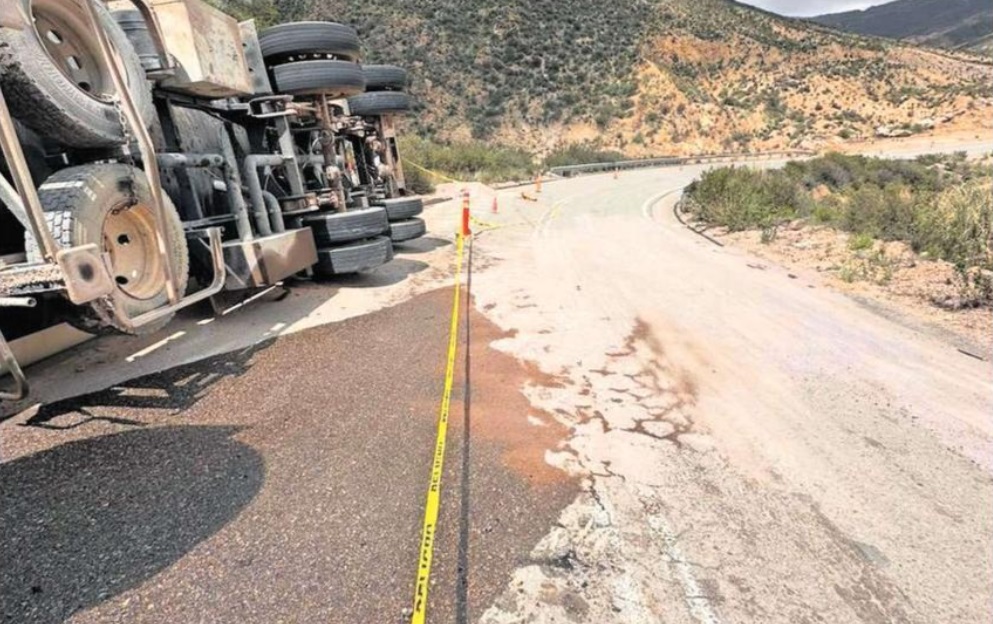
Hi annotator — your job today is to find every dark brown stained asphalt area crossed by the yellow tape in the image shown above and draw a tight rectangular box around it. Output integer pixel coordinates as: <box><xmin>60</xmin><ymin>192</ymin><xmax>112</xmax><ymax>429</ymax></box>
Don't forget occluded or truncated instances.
<box><xmin>0</xmin><ymin>288</ymin><xmax>576</xmax><ymax>624</ymax></box>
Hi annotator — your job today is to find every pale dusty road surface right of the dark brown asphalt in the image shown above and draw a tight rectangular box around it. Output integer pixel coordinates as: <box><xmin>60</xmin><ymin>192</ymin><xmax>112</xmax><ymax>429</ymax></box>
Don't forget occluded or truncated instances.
<box><xmin>468</xmin><ymin>168</ymin><xmax>993</xmax><ymax>623</ymax></box>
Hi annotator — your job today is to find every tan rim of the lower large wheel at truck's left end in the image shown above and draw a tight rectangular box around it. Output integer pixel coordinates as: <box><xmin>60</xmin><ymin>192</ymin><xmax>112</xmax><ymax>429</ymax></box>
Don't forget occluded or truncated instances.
<box><xmin>103</xmin><ymin>204</ymin><xmax>165</xmax><ymax>299</ymax></box>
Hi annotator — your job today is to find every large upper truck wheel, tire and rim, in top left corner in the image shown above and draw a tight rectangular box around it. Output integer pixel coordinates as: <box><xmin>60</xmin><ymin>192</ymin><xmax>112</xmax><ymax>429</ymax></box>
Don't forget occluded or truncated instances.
<box><xmin>0</xmin><ymin>0</ymin><xmax>155</xmax><ymax>148</ymax></box>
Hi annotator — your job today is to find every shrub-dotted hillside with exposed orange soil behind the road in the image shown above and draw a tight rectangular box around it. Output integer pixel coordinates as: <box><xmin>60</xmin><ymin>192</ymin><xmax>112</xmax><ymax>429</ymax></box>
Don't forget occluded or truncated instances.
<box><xmin>242</xmin><ymin>0</ymin><xmax>993</xmax><ymax>156</ymax></box>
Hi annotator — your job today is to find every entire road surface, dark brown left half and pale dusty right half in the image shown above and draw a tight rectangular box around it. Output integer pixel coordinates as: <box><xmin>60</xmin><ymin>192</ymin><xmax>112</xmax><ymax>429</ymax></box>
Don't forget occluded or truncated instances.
<box><xmin>0</xmin><ymin>149</ymin><xmax>993</xmax><ymax>623</ymax></box>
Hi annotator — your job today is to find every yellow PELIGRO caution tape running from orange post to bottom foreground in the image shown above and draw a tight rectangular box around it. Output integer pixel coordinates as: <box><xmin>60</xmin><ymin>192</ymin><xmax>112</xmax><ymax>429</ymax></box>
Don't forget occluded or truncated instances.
<box><xmin>410</xmin><ymin>230</ymin><xmax>465</xmax><ymax>624</ymax></box>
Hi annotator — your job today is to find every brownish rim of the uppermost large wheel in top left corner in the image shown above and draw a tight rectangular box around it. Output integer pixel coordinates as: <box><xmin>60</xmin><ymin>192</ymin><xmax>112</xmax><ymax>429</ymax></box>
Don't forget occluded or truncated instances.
<box><xmin>28</xmin><ymin>0</ymin><xmax>114</xmax><ymax>101</ymax></box>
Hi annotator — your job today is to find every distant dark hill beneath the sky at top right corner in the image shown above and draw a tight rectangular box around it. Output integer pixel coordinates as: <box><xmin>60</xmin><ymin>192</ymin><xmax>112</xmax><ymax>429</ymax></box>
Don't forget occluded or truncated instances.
<box><xmin>811</xmin><ymin>0</ymin><xmax>993</xmax><ymax>53</ymax></box>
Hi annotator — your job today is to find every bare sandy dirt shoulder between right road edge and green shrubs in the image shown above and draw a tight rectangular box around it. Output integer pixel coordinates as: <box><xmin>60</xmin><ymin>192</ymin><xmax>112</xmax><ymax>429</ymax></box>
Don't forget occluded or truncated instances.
<box><xmin>708</xmin><ymin>221</ymin><xmax>993</xmax><ymax>359</ymax></box>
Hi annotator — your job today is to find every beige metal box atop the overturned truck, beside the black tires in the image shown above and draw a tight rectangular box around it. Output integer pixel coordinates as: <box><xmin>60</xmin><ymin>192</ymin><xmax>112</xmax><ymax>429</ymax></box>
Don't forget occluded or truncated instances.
<box><xmin>150</xmin><ymin>0</ymin><xmax>253</xmax><ymax>98</ymax></box>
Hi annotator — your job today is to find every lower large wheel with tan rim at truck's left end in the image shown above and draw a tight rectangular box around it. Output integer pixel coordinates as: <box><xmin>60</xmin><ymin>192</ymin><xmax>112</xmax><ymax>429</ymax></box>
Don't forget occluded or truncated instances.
<box><xmin>26</xmin><ymin>164</ymin><xmax>190</xmax><ymax>334</ymax></box>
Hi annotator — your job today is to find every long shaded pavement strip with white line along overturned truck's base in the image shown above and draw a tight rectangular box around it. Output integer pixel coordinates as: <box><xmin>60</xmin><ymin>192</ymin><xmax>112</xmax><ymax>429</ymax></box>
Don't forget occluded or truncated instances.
<box><xmin>0</xmin><ymin>241</ymin><xmax>438</xmax><ymax>429</ymax></box>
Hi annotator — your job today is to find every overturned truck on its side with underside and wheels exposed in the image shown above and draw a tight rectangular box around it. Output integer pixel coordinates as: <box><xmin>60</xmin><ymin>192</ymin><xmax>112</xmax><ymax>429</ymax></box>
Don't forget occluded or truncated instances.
<box><xmin>0</xmin><ymin>0</ymin><xmax>424</xmax><ymax>399</ymax></box>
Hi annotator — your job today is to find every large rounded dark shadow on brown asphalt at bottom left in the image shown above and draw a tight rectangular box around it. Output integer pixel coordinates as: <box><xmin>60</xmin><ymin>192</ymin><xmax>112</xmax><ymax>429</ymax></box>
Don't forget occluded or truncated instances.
<box><xmin>0</xmin><ymin>426</ymin><xmax>265</xmax><ymax>624</ymax></box>
